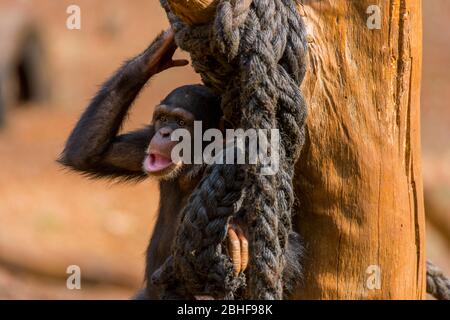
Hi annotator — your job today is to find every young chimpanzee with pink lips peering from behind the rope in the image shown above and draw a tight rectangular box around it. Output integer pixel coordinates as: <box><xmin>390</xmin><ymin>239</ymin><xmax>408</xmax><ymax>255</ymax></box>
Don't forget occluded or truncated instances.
<box><xmin>59</xmin><ymin>29</ymin><xmax>298</xmax><ymax>299</ymax></box>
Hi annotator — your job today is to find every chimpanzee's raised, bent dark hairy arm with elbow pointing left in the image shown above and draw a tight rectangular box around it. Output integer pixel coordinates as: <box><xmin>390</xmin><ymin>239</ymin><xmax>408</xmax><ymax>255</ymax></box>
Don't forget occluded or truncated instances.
<box><xmin>59</xmin><ymin>30</ymin><xmax>187</xmax><ymax>178</ymax></box>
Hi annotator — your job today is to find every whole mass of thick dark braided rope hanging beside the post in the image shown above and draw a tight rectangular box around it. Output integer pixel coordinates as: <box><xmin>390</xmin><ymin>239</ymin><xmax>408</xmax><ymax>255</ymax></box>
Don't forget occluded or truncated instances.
<box><xmin>153</xmin><ymin>0</ymin><xmax>307</xmax><ymax>299</ymax></box>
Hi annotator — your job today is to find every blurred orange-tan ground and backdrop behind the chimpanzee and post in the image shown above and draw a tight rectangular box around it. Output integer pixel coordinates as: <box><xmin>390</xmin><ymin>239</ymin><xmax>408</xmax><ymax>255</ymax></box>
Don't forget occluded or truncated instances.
<box><xmin>0</xmin><ymin>0</ymin><xmax>450</xmax><ymax>299</ymax></box>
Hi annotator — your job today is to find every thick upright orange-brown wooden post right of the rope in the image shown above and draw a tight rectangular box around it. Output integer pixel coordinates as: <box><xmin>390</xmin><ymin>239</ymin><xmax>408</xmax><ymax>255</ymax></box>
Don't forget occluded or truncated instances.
<box><xmin>165</xmin><ymin>0</ymin><xmax>425</xmax><ymax>299</ymax></box>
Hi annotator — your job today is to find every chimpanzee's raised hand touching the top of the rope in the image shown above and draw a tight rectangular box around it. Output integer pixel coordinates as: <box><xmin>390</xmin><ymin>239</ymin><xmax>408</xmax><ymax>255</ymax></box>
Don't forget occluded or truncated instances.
<box><xmin>148</xmin><ymin>28</ymin><xmax>189</xmax><ymax>74</ymax></box>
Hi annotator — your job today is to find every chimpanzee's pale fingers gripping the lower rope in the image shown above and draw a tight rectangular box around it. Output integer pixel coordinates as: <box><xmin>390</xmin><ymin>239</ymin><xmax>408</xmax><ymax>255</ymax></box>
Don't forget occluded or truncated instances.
<box><xmin>228</xmin><ymin>222</ymin><xmax>248</xmax><ymax>274</ymax></box>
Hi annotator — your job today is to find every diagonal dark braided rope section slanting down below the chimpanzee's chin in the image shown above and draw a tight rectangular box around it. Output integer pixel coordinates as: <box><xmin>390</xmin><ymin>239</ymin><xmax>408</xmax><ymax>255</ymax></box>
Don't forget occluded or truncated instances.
<box><xmin>152</xmin><ymin>165</ymin><xmax>244</xmax><ymax>299</ymax></box>
